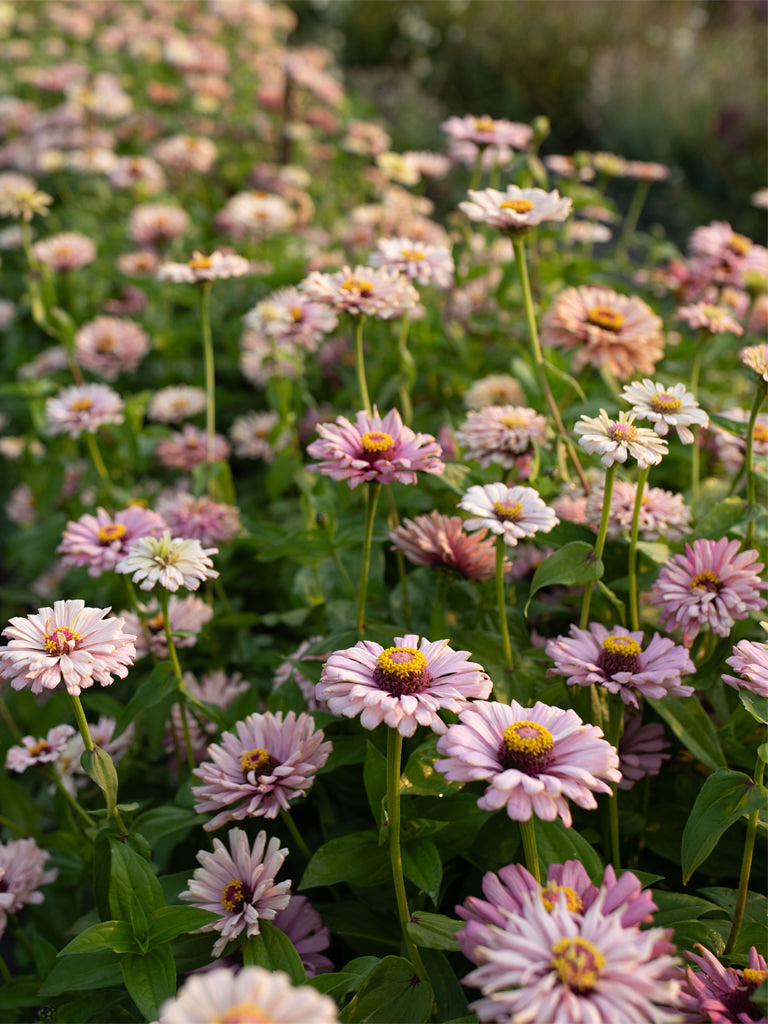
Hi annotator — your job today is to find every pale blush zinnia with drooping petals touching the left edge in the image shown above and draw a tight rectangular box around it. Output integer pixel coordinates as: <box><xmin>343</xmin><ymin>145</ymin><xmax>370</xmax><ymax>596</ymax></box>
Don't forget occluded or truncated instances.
<box><xmin>0</xmin><ymin>601</ymin><xmax>136</xmax><ymax>696</ymax></box>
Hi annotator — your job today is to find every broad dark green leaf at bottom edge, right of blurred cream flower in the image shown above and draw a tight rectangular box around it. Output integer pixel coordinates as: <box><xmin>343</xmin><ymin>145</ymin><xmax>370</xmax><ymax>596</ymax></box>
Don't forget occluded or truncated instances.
<box><xmin>339</xmin><ymin>956</ymin><xmax>434</xmax><ymax>1024</ymax></box>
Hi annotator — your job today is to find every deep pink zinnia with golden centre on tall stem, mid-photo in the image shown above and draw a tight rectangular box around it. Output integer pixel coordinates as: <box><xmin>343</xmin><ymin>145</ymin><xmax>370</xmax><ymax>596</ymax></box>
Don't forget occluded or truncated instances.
<box><xmin>306</xmin><ymin>407</ymin><xmax>445</xmax><ymax>488</ymax></box>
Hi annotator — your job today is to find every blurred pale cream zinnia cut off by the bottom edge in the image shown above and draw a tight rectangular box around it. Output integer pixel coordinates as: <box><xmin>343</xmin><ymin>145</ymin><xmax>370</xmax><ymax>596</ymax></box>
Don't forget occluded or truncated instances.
<box><xmin>159</xmin><ymin>967</ymin><xmax>339</xmax><ymax>1024</ymax></box>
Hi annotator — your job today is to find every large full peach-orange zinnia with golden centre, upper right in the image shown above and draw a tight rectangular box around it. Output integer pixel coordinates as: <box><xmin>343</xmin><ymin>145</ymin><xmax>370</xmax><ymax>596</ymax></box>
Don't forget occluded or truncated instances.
<box><xmin>542</xmin><ymin>286</ymin><xmax>665</xmax><ymax>380</ymax></box>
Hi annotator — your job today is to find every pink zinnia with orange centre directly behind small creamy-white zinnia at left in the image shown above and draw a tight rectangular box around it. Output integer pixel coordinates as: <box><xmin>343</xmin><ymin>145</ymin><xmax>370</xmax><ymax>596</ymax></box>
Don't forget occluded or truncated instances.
<box><xmin>56</xmin><ymin>505</ymin><xmax>167</xmax><ymax>577</ymax></box>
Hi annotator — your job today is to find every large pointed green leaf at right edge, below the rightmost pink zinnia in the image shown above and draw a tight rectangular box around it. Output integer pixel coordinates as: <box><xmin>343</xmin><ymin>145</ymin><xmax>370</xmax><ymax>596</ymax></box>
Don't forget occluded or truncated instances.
<box><xmin>681</xmin><ymin>768</ymin><xmax>768</xmax><ymax>882</ymax></box>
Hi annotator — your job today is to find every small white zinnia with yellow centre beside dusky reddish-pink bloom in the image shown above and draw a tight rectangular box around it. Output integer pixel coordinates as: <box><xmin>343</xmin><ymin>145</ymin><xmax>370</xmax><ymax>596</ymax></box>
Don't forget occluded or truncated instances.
<box><xmin>459</xmin><ymin>483</ymin><xmax>560</xmax><ymax>548</ymax></box>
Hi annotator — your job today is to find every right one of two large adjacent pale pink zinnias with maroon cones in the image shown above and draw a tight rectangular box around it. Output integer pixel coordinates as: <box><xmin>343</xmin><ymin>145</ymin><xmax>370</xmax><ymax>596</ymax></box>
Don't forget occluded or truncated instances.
<box><xmin>435</xmin><ymin>700</ymin><xmax>622</xmax><ymax>826</ymax></box>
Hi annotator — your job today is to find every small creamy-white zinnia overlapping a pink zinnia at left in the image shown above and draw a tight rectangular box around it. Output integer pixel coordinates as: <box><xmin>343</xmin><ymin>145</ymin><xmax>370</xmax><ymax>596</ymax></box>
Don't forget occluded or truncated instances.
<box><xmin>115</xmin><ymin>530</ymin><xmax>218</xmax><ymax>592</ymax></box>
